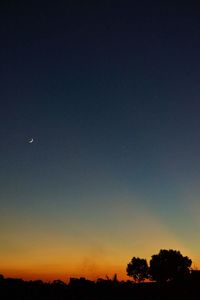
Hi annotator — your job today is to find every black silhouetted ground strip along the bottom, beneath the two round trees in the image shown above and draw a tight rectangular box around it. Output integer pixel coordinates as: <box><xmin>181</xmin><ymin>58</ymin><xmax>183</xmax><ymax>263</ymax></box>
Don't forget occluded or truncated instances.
<box><xmin>0</xmin><ymin>278</ymin><xmax>200</xmax><ymax>300</ymax></box>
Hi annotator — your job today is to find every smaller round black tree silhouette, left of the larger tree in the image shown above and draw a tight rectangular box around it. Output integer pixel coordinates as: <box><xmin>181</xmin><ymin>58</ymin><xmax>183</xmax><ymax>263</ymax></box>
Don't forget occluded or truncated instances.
<box><xmin>126</xmin><ymin>257</ymin><xmax>149</xmax><ymax>282</ymax></box>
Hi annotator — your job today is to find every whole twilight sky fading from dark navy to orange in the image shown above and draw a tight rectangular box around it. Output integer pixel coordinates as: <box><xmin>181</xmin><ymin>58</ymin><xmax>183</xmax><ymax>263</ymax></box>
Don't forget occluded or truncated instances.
<box><xmin>0</xmin><ymin>0</ymin><xmax>200</xmax><ymax>280</ymax></box>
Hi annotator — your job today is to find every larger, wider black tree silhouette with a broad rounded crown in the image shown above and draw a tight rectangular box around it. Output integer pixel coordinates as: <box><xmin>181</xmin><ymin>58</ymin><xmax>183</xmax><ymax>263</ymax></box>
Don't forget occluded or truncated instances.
<box><xmin>149</xmin><ymin>249</ymin><xmax>192</xmax><ymax>281</ymax></box>
